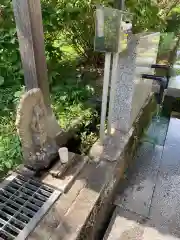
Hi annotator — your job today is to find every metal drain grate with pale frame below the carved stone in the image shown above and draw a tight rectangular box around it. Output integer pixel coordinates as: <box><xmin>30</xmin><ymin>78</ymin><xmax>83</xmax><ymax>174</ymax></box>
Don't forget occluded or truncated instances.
<box><xmin>0</xmin><ymin>175</ymin><xmax>61</xmax><ymax>240</ymax></box>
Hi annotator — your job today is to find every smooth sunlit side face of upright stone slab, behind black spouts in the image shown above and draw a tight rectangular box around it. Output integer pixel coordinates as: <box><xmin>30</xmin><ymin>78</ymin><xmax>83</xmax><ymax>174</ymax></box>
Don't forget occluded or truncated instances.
<box><xmin>130</xmin><ymin>33</ymin><xmax>160</xmax><ymax>128</ymax></box>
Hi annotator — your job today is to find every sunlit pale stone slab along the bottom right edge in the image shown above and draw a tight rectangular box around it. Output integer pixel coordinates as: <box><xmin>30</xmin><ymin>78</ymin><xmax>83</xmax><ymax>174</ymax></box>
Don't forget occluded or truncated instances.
<box><xmin>103</xmin><ymin>207</ymin><xmax>180</xmax><ymax>240</ymax></box>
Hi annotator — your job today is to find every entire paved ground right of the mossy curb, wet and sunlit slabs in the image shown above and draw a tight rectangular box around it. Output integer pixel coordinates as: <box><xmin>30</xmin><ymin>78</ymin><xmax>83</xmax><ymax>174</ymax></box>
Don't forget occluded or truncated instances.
<box><xmin>104</xmin><ymin>117</ymin><xmax>180</xmax><ymax>240</ymax></box>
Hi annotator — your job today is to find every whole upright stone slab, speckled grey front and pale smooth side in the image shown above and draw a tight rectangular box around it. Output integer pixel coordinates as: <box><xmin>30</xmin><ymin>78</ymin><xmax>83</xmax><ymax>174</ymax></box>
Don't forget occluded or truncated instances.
<box><xmin>110</xmin><ymin>33</ymin><xmax>160</xmax><ymax>132</ymax></box>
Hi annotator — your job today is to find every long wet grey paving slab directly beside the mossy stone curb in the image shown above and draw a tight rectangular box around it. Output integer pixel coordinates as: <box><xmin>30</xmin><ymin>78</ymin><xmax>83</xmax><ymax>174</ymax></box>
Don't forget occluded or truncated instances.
<box><xmin>116</xmin><ymin>143</ymin><xmax>163</xmax><ymax>217</ymax></box>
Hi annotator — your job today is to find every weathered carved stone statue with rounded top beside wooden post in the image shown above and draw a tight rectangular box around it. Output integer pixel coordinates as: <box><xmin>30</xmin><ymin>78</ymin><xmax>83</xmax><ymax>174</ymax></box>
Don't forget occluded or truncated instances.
<box><xmin>16</xmin><ymin>88</ymin><xmax>58</xmax><ymax>171</ymax></box>
